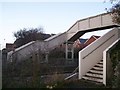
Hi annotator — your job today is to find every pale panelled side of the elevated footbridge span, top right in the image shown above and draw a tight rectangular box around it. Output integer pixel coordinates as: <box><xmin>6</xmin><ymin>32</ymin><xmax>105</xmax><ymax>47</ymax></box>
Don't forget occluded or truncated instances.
<box><xmin>67</xmin><ymin>13</ymin><xmax>114</xmax><ymax>33</ymax></box>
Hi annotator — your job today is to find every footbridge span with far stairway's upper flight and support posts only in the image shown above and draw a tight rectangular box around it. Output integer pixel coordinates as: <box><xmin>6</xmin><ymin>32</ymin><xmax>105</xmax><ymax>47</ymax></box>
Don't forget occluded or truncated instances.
<box><xmin>45</xmin><ymin>13</ymin><xmax>119</xmax><ymax>59</ymax></box>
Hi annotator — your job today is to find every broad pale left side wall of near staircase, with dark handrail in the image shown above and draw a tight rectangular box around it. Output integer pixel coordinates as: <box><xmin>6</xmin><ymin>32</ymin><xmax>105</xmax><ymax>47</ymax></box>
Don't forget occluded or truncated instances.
<box><xmin>79</xmin><ymin>28</ymin><xmax>119</xmax><ymax>79</ymax></box>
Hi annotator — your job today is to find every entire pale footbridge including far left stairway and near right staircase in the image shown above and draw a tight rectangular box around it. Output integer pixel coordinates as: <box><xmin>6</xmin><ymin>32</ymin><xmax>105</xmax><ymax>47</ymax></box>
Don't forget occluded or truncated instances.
<box><xmin>8</xmin><ymin>13</ymin><xmax>120</xmax><ymax>85</ymax></box>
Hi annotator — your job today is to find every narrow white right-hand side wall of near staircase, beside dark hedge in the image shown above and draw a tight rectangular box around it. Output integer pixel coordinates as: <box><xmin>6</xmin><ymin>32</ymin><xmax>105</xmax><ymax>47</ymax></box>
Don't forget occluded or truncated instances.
<box><xmin>103</xmin><ymin>37</ymin><xmax>120</xmax><ymax>85</ymax></box>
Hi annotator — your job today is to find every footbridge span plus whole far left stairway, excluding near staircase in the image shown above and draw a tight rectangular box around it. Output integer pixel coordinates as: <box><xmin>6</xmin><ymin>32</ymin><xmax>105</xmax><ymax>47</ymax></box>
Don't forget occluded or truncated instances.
<box><xmin>8</xmin><ymin>13</ymin><xmax>118</xmax><ymax>62</ymax></box>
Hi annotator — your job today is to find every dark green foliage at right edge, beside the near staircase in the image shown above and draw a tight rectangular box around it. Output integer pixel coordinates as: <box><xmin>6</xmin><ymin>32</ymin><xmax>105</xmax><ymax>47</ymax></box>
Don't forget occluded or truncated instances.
<box><xmin>110</xmin><ymin>41</ymin><xmax>120</xmax><ymax>88</ymax></box>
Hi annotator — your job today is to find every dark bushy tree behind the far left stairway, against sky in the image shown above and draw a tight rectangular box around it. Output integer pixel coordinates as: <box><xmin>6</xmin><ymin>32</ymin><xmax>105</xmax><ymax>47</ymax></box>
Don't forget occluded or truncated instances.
<box><xmin>14</xmin><ymin>28</ymin><xmax>51</xmax><ymax>48</ymax></box>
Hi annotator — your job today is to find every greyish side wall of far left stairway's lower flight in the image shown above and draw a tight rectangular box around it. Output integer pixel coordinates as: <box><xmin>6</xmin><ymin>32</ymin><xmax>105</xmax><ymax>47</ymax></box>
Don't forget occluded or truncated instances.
<box><xmin>7</xmin><ymin>41</ymin><xmax>46</xmax><ymax>62</ymax></box>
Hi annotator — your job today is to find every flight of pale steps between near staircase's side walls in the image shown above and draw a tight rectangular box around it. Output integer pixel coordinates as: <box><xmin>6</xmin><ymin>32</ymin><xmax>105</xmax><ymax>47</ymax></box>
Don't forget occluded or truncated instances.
<box><xmin>82</xmin><ymin>60</ymin><xmax>103</xmax><ymax>83</ymax></box>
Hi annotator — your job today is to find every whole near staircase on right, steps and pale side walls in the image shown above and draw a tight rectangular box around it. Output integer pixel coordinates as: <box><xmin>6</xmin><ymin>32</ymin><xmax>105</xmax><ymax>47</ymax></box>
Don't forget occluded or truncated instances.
<box><xmin>79</xmin><ymin>27</ymin><xmax>120</xmax><ymax>85</ymax></box>
